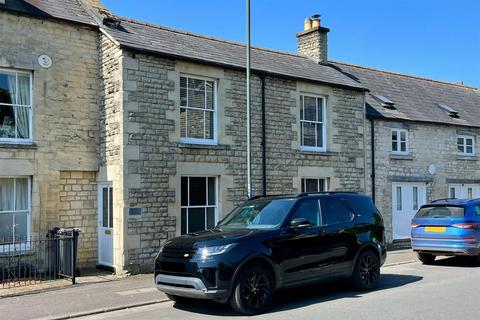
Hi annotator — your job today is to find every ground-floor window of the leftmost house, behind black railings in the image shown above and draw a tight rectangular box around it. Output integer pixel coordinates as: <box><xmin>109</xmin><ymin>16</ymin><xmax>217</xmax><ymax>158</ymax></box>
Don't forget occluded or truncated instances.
<box><xmin>0</xmin><ymin>177</ymin><xmax>31</xmax><ymax>243</ymax></box>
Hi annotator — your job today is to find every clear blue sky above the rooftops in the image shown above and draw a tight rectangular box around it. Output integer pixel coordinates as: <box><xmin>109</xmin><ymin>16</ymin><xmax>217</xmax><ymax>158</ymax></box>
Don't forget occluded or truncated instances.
<box><xmin>103</xmin><ymin>0</ymin><xmax>480</xmax><ymax>87</ymax></box>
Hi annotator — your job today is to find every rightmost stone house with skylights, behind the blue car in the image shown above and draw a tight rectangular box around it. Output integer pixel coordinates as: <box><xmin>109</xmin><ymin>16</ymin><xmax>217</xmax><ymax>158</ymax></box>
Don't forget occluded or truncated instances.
<box><xmin>333</xmin><ymin>62</ymin><xmax>480</xmax><ymax>244</ymax></box>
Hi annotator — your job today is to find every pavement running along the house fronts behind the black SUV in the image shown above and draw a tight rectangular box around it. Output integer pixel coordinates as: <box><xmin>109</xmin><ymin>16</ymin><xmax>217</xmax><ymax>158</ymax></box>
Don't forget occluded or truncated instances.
<box><xmin>0</xmin><ymin>250</ymin><xmax>416</xmax><ymax>320</ymax></box>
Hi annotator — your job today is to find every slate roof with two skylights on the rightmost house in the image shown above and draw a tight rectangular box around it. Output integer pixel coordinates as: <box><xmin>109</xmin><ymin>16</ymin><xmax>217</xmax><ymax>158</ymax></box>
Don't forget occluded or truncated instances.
<box><xmin>330</xmin><ymin>61</ymin><xmax>480</xmax><ymax>127</ymax></box>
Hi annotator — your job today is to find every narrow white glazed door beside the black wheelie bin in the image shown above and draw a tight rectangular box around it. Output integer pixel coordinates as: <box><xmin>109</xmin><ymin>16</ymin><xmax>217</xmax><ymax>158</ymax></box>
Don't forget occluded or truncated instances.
<box><xmin>98</xmin><ymin>183</ymin><xmax>113</xmax><ymax>268</ymax></box>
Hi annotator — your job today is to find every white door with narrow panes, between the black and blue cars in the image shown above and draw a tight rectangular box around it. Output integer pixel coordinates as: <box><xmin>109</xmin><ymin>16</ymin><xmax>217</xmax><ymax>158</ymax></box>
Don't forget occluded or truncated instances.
<box><xmin>392</xmin><ymin>183</ymin><xmax>427</xmax><ymax>240</ymax></box>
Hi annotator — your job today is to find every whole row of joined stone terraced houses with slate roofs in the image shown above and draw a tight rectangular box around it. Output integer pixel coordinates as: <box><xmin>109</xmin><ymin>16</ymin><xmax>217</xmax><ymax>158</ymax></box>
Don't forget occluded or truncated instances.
<box><xmin>0</xmin><ymin>0</ymin><xmax>480</xmax><ymax>273</ymax></box>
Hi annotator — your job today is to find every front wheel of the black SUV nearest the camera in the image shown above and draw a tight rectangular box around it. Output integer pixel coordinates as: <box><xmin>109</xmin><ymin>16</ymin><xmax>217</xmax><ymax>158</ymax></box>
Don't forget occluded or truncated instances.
<box><xmin>230</xmin><ymin>263</ymin><xmax>274</xmax><ymax>315</ymax></box>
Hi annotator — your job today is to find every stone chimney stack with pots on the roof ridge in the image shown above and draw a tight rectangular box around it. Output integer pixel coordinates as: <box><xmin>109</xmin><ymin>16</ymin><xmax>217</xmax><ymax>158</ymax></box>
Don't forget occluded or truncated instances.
<box><xmin>297</xmin><ymin>14</ymin><xmax>330</xmax><ymax>63</ymax></box>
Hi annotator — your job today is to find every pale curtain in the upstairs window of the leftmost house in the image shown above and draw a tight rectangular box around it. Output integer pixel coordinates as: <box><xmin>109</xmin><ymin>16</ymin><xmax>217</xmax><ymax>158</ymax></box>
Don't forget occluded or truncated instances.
<box><xmin>8</xmin><ymin>75</ymin><xmax>30</xmax><ymax>139</ymax></box>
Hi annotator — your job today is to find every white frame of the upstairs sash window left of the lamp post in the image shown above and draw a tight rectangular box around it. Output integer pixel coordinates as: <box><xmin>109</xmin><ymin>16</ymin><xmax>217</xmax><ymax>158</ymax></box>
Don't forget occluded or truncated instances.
<box><xmin>178</xmin><ymin>74</ymin><xmax>218</xmax><ymax>145</ymax></box>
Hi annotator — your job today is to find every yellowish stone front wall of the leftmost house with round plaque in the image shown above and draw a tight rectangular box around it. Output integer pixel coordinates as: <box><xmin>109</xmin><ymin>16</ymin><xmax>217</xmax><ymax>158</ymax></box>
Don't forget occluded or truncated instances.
<box><xmin>0</xmin><ymin>11</ymin><xmax>99</xmax><ymax>268</ymax></box>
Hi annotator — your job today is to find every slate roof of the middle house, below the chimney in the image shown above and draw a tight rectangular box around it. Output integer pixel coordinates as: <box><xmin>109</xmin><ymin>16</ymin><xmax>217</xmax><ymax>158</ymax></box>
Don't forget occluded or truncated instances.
<box><xmin>106</xmin><ymin>18</ymin><xmax>365</xmax><ymax>90</ymax></box>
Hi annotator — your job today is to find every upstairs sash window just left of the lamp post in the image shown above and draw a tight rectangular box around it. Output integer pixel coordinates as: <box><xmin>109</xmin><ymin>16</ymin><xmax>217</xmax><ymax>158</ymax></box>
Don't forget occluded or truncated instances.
<box><xmin>180</xmin><ymin>77</ymin><xmax>217</xmax><ymax>144</ymax></box>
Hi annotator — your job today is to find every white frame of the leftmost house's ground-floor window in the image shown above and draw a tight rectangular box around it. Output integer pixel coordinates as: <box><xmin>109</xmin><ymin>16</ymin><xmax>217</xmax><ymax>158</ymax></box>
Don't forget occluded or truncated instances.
<box><xmin>0</xmin><ymin>176</ymin><xmax>32</xmax><ymax>253</ymax></box>
